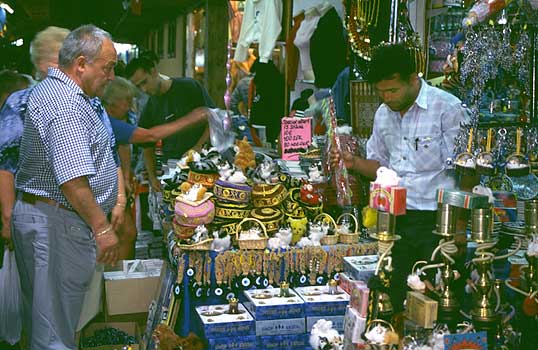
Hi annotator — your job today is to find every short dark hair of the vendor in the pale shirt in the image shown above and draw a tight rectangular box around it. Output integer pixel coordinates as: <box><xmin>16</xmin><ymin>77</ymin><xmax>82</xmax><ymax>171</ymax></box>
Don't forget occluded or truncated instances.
<box><xmin>368</xmin><ymin>44</ymin><xmax>416</xmax><ymax>84</ymax></box>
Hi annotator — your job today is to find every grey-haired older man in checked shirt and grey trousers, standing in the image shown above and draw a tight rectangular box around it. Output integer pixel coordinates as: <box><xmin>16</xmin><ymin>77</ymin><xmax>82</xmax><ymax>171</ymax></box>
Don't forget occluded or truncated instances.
<box><xmin>12</xmin><ymin>25</ymin><xmax>118</xmax><ymax>349</ymax></box>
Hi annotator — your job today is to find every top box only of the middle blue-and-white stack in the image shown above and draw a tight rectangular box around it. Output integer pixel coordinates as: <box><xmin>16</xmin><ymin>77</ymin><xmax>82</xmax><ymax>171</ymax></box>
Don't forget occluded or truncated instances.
<box><xmin>244</xmin><ymin>288</ymin><xmax>305</xmax><ymax>320</ymax></box>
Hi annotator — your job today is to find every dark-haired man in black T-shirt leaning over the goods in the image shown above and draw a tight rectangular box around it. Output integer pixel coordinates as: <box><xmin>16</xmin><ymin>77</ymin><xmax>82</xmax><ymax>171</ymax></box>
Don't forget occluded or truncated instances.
<box><xmin>125</xmin><ymin>58</ymin><xmax>214</xmax><ymax>191</ymax></box>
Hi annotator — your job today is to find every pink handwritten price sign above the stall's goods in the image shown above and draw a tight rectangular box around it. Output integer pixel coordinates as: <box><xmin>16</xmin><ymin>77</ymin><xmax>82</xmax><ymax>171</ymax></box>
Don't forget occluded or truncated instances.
<box><xmin>280</xmin><ymin>117</ymin><xmax>312</xmax><ymax>160</ymax></box>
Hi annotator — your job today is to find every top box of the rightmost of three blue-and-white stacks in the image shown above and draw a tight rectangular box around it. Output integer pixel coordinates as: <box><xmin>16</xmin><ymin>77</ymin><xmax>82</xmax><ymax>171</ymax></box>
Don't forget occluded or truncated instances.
<box><xmin>294</xmin><ymin>286</ymin><xmax>349</xmax><ymax>317</ymax></box>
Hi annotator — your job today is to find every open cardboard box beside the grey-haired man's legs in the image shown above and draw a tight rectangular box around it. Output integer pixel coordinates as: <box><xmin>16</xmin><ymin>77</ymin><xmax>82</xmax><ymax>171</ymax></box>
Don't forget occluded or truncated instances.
<box><xmin>104</xmin><ymin>260</ymin><xmax>164</xmax><ymax>316</ymax></box>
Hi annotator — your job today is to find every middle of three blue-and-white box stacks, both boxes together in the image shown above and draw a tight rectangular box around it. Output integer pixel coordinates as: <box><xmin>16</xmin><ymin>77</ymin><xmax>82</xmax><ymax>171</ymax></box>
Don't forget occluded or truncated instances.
<box><xmin>244</xmin><ymin>288</ymin><xmax>306</xmax><ymax>350</ymax></box>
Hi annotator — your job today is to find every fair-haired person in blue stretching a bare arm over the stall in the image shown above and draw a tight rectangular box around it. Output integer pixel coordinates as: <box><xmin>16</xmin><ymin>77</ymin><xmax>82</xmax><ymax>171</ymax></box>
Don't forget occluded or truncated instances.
<box><xmin>101</xmin><ymin>77</ymin><xmax>209</xmax><ymax>259</ymax></box>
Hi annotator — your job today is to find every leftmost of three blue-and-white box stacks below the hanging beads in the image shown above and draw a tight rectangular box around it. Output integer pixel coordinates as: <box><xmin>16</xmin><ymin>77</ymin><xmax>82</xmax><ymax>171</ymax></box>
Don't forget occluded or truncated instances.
<box><xmin>196</xmin><ymin>304</ymin><xmax>257</xmax><ymax>350</ymax></box>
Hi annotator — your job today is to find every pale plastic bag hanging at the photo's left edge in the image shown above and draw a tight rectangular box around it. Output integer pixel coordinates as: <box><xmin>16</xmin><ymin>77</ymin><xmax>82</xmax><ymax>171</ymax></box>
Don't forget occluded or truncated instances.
<box><xmin>0</xmin><ymin>248</ymin><xmax>22</xmax><ymax>345</ymax></box>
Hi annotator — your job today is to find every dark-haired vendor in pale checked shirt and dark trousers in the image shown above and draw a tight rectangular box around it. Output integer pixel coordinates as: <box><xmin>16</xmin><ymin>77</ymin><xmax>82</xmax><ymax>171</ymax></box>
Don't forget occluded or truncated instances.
<box><xmin>331</xmin><ymin>44</ymin><xmax>476</xmax><ymax>312</ymax></box>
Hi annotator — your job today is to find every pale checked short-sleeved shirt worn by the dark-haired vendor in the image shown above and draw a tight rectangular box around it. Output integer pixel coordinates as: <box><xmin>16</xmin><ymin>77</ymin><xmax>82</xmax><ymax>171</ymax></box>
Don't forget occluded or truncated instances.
<box><xmin>366</xmin><ymin>79</ymin><xmax>467</xmax><ymax>210</ymax></box>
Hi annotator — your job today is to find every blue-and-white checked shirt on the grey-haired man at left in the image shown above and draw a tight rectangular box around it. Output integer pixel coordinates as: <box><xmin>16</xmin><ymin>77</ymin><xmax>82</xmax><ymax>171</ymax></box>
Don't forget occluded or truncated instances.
<box><xmin>16</xmin><ymin>68</ymin><xmax>118</xmax><ymax>213</ymax></box>
